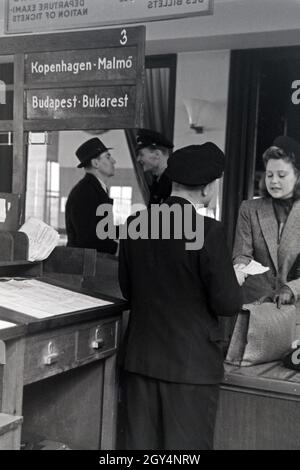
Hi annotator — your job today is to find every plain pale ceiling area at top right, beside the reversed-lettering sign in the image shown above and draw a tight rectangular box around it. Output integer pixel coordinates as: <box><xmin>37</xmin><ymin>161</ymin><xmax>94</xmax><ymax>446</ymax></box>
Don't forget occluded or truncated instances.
<box><xmin>0</xmin><ymin>0</ymin><xmax>300</xmax><ymax>54</ymax></box>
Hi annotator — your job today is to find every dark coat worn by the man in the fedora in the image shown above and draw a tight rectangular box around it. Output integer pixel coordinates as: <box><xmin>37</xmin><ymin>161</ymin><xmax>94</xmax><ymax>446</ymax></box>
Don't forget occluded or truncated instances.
<box><xmin>66</xmin><ymin>173</ymin><xmax>117</xmax><ymax>254</ymax></box>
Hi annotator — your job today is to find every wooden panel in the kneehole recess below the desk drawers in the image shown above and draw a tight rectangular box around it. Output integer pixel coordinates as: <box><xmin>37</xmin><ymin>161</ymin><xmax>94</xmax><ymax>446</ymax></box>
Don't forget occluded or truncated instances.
<box><xmin>22</xmin><ymin>360</ymin><xmax>105</xmax><ymax>450</ymax></box>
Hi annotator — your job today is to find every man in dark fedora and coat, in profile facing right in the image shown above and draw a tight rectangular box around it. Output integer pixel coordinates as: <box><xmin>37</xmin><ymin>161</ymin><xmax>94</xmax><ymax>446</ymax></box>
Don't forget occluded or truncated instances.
<box><xmin>66</xmin><ymin>137</ymin><xmax>118</xmax><ymax>254</ymax></box>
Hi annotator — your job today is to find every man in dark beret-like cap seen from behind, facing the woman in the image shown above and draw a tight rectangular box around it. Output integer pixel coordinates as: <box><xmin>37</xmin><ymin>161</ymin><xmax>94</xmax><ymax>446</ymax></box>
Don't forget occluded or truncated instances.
<box><xmin>119</xmin><ymin>142</ymin><xmax>241</xmax><ymax>450</ymax></box>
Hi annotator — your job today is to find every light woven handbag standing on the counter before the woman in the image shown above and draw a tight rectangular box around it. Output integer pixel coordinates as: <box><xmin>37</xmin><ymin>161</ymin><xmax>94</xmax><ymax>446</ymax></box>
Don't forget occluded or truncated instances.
<box><xmin>225</xmin><ymin>303</ymin><xmax>296</xmax><ymax>366</ymax></box>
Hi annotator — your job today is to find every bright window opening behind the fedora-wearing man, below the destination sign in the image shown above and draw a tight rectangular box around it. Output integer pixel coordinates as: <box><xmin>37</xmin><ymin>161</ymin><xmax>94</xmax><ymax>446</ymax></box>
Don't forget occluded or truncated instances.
<box><xmin>25</xmin><ymin>130</ymin><xmax>143</xmax><ymax>241</ymax></box>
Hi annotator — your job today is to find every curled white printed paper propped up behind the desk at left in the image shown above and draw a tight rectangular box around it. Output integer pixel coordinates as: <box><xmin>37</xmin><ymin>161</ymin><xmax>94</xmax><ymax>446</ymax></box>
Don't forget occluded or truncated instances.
<box><xmin>19</xmin><ymin>217</ymin><xmax>59</xmax><ymax>261</ymax></box>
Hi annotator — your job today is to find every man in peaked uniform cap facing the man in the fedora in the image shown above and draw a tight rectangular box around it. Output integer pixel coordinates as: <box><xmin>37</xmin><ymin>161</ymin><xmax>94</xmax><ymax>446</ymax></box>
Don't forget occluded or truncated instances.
<box><xmin>136</xmin><ymin>129</ymin><xmax>173</xmax><ymax>205</ymax></box>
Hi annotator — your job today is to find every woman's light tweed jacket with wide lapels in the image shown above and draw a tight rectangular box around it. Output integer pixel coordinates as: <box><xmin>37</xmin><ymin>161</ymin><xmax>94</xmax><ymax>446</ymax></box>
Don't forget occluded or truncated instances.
<box><xmin>233</xmin><ymin>198</ymin><xmax>300</xmax><ymax>302</ymax></box>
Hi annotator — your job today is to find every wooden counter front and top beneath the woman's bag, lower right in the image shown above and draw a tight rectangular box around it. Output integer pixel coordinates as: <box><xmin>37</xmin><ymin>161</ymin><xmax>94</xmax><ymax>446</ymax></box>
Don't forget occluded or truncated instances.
<box><xmin>215</xmin><ymin>362</ymin><xmax>300</xmax><ymax>450</ymax></box>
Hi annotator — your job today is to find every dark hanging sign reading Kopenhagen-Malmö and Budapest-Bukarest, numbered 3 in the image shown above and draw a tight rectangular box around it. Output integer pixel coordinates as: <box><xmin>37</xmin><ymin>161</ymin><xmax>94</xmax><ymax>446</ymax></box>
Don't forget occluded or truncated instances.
<box><xmin>24</xmin><ymin>26</ymin><xmax>145</xmax><ymax>129</ymax></box>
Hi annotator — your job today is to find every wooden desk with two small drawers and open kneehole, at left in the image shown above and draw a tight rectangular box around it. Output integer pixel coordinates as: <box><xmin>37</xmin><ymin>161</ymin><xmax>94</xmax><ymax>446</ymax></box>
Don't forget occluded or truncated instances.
<box><xmin>0</xmin><ymin>262</ymin><xmax>127</xmax><ymax>449</ymax></box>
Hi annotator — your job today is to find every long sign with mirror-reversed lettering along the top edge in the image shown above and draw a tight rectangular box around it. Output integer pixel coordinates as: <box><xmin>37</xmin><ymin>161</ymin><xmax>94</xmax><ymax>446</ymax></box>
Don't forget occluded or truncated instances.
<box><xmin>5</xmin><ymin>0</ymin><xmax>213</xmax><ymax>33</ymax></box>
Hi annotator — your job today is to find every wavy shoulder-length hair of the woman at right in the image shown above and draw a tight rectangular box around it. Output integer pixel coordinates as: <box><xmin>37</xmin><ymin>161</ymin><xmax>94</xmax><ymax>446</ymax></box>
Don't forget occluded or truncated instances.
<box><xmin>259</xmin><ymin>146</ymin><xmax>300</xmax><ymax>200</ymax></box>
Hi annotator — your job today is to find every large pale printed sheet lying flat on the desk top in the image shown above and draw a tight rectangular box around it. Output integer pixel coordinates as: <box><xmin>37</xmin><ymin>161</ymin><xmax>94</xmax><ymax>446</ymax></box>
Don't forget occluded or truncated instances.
<box><xmin>0</xmin><ymin>279</ymin><xmax>112</xmax><ymax>318</ymax></box>
